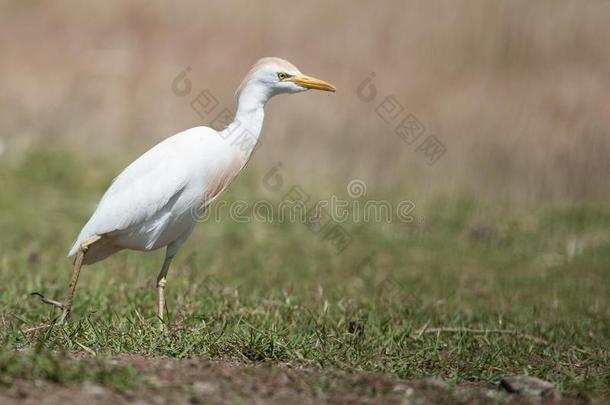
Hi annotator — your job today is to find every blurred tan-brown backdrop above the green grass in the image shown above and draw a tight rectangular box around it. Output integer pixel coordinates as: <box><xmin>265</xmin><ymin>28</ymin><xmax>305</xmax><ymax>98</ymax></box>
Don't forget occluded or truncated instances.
<box><xmin>0</xmin><ymin>0</ymin><xmax>610</xmax><ymax>204</ymax></box>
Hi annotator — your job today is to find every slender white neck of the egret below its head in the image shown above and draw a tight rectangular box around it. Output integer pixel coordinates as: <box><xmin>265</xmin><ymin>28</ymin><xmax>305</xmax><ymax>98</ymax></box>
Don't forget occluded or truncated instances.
<box><xmin>216</xmin><ymin>83</ymin><xmax>273</xmax><ymax>157</ymax></box>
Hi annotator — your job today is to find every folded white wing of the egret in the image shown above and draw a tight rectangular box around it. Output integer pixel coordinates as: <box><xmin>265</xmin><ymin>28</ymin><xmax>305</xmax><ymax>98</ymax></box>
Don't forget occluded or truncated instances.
<box><xmin>69</xmin><ymin>127</ymin><xmax>218</xmax><ymax>256</ymax></box>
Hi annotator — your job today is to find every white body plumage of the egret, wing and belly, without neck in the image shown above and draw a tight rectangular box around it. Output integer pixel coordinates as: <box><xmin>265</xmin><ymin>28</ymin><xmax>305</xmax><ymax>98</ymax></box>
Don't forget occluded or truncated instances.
<box><xmin>69</xmin><ymin>127</ymin><xmax>238</xmax><ymax>256</ymax></box>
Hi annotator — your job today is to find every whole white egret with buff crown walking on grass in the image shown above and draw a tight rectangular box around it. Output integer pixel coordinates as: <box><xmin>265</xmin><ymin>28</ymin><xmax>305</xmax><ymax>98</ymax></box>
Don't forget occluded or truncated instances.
<box><xmin>35</xmin><ymin>58</ymin><xmax>335</xmax><ymax>322</ymax></box>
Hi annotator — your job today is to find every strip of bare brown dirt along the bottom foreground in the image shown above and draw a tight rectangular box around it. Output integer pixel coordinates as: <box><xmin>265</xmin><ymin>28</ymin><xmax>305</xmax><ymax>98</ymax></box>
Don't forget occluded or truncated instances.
<box><xmin>0</xmin><ymin>355</ymin><xmax>586</xmax><ymax>405</ymax></box>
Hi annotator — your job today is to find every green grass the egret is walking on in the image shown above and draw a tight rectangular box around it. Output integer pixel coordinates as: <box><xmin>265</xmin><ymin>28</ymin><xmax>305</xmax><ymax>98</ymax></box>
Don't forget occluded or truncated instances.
<box><xmin>0</xmin><ymin>151</ymin><xmax>610</xmax><ymax>396</ymax></box>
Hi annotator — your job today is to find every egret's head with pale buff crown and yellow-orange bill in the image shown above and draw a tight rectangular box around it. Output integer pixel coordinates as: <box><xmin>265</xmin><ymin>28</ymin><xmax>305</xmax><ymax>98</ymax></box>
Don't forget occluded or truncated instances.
<box><xmin>235</xmin><ymin>58</ymin><xmax>336</xmax><ymax>105</ymax></box>
